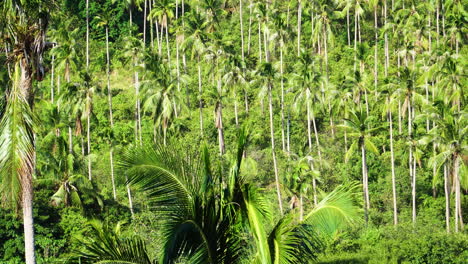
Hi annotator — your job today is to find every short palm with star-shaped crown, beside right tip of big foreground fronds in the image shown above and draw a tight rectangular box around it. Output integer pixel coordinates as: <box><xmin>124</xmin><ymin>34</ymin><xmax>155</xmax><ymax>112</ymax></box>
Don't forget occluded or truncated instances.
<box><xmin>341</xmin><ymin>108</ymin><xmax>380</xmax><ymax>225</ymax></box>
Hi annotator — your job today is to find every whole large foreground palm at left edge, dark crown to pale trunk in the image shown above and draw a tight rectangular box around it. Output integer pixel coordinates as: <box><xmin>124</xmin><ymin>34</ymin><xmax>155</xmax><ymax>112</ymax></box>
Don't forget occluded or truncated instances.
<box><xmin>0</xmin><ymin>0</ymin><xmax>53</xmax><ymax>264</ymax></box>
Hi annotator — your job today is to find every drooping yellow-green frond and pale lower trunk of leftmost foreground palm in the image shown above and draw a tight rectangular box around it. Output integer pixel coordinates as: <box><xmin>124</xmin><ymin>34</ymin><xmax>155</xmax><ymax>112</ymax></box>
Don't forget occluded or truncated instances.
<box><xmin>0</xmin><ymin>65</ymin><xmax>36</xmax><ymax>264</ymax></box>
